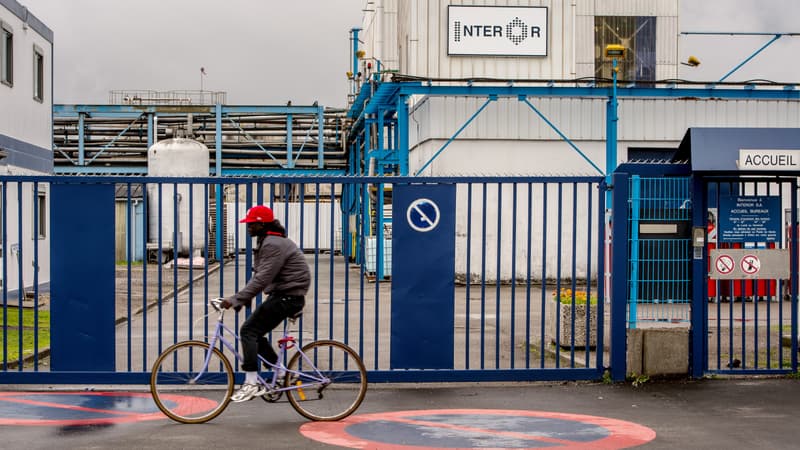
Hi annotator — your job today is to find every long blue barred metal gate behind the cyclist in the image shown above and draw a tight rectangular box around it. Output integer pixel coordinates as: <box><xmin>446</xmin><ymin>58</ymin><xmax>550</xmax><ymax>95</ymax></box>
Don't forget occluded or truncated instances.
<box><xmin>0</xmin><ymin>177</ymin><xmax>610</xmax><ymax>384</ymax></box>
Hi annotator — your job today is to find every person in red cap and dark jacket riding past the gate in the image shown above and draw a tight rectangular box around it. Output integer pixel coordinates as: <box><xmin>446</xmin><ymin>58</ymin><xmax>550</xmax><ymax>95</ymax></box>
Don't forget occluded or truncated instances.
<box><xmin>221</xmin><ymin>205</ymin><xmax>311</xmax><ymax>402</ymax></box>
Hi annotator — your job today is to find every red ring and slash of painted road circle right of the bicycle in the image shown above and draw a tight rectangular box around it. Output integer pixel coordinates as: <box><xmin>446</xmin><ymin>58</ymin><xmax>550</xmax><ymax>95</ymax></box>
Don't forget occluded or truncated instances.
<box><xmin>300</xmin><ymin>409</ymin><xmax>656</xmax><ymax>450</ymax></box>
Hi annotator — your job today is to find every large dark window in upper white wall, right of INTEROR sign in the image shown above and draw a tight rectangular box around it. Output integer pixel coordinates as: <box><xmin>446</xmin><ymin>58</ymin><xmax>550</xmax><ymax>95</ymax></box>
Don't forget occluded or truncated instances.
<box><xmin>594</xmin><ymin>16</ymin><xmax>656</xmax><ymax>84</ymax></box>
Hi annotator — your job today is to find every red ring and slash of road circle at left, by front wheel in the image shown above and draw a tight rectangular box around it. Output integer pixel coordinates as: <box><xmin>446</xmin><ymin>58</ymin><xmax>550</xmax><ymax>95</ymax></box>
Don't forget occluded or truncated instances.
<box><xmin>0</xmin><ymin>391</ymin><xmax>217</xmax><ymax>426</ymax></box>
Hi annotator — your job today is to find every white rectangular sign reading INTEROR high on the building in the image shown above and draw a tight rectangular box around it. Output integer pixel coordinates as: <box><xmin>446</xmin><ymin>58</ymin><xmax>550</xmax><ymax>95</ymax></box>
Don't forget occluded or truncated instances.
<box><xmin>447</xmin><ymin>5</ymin><xmax>547</xmax><ymax>56</ymax></box>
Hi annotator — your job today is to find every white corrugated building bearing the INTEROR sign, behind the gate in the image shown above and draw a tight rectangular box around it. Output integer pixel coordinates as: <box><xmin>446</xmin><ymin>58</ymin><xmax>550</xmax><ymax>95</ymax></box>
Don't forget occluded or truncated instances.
<box><xmin>359</xmin><ymin>0</ymin><xmax>800</xmax><ymax>279</ymax></box>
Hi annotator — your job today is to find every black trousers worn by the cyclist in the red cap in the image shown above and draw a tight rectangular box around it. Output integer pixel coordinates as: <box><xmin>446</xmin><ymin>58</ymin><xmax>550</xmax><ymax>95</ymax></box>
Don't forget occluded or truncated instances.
<box><xmin>239</xmin><ymin>294</ymin><xmax>306</xmax><ymax>372</ymax></box>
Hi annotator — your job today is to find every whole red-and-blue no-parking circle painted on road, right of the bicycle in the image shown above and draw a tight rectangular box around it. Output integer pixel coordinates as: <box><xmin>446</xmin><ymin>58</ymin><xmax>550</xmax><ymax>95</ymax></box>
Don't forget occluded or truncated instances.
<box><xmin>300</xmin><ymin>409</ymin><xmax>656</xmax><ymax>450</ymax></box>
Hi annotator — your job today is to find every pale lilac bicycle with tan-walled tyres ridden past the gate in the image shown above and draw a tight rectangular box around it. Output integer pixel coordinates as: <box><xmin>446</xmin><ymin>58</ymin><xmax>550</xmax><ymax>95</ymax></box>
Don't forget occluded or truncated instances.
<box><xmin>150</xmin><ymin>299</ymin><xmax>367</xmax><ymax>423</ymax></box>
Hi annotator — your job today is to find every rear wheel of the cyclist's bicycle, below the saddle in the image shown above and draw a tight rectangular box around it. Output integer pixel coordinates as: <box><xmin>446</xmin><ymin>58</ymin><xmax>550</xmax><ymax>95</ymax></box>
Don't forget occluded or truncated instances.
<box><xmin>285</xmin><ymin>341</ymin><xmax>367</xmax><ymax>421</ymax></box>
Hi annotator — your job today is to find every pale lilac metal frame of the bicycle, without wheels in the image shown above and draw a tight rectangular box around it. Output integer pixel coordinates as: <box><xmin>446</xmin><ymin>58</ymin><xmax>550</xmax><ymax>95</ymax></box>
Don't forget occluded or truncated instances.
<box><xmin>193</xmin><ymin>310</ymin><xmax>330</xmax><ymax>392</ymax></box>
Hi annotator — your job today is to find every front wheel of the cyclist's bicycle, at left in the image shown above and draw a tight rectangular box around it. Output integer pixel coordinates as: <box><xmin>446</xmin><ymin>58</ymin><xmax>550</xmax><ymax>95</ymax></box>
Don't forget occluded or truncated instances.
<box><xmin>150</xmin><ymin>341</ymin><xmax>233</xmax><ymax>423</ymax></box>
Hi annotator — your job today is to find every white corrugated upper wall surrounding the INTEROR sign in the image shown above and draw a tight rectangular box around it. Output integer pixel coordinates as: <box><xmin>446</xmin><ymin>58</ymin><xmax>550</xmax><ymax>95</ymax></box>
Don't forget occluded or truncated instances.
<box><xmin>363</xmin><ymin>0</ymin><xmax>679</xmax><ymax>79</ymax></box>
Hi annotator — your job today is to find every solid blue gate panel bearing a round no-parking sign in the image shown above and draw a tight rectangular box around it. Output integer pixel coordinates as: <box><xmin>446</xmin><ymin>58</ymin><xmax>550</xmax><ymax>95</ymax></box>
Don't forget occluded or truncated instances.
<box><xmin>390</xmin><ymin>185</ymin><xmax>456</xmax><ymax>369</ymax></box>
